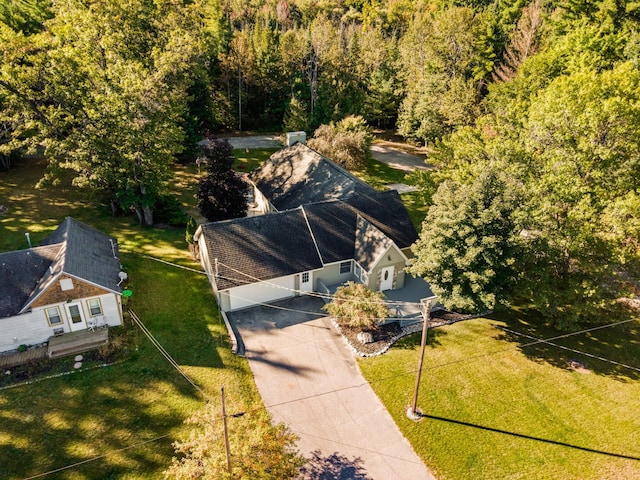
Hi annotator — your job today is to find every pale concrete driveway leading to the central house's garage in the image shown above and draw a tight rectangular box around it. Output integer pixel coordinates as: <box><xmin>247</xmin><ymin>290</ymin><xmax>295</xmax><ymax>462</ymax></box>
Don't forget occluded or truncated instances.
<box><xmin>229</xmin><ymin>297</ymin><xmax>434</xmax><ymax>480</ymax></box>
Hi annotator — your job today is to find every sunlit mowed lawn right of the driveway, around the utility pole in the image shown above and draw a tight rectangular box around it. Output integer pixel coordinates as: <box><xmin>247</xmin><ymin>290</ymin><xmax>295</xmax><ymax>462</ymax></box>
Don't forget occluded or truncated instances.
<box><xmin>360</xmin><ymin>310</ymin><xmax>640</xmax><ymax>480</ymax></box>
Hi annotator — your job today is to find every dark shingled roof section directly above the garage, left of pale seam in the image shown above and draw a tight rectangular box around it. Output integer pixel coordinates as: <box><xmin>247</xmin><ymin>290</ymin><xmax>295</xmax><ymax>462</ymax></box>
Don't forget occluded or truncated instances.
<box><xmin>202</xmin><ymin>210</ymin><xmax>322</xmax><ymax>290</ymax></box>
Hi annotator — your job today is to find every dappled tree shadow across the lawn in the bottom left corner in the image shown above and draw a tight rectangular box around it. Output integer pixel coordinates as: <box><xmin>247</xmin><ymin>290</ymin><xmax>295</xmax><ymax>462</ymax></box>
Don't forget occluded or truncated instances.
<box><xmin>0</xmin><ymin>363</ymin><xmax>198</xmax><ymax>478</ymax></box>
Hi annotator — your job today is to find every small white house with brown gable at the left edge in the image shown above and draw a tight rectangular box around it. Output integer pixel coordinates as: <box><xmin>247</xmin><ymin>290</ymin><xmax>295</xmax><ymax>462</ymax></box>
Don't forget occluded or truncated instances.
<box><xmin>0</xmin><ymin>217</ymin><xmax>122</xmax><ymax>352</ymax></box>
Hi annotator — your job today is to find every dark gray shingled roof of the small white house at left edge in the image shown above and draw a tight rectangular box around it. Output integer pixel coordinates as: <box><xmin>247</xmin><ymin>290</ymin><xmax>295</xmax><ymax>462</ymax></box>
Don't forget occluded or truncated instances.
<box><xmin>0</xmin><ymin>217</ymin><xmax>121</xmax><ymax>317</ymax></box>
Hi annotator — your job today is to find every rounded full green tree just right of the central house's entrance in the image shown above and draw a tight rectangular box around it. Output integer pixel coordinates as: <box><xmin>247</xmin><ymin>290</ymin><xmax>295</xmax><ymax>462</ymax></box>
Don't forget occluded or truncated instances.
<box><xmin>410</xmin><ymin>169</ymin><xmax>518</xmax><ymax>311</ymax></box>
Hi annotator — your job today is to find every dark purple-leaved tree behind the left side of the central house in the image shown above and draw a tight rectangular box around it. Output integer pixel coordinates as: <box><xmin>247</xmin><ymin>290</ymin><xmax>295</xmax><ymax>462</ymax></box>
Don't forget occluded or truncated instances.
<box><xmin>198</xmin><ymin>140</ymin><xmax>248</xmax><ymax>222</ymax></box>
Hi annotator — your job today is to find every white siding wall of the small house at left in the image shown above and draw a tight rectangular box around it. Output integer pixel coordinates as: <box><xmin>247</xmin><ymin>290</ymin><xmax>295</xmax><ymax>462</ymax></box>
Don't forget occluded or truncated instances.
<box><xmin>0</xmin><ymin>293</ymin><xmax>122</xmax><ymax>352</ymax></box>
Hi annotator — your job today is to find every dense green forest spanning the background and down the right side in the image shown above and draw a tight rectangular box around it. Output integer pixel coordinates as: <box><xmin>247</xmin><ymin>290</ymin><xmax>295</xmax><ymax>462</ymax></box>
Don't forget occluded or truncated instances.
<box><xmin>0</xmin><ymin>0</ymin><xmax>640</xmax><ymax>328</ymax></box>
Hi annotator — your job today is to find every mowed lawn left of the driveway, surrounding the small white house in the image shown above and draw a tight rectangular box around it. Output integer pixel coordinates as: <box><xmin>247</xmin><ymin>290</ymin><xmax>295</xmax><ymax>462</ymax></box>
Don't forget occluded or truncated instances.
<box><xmin>0</xmin><ymin>162</ymin><xmax>261</xmax><ymax>479</ymax></box>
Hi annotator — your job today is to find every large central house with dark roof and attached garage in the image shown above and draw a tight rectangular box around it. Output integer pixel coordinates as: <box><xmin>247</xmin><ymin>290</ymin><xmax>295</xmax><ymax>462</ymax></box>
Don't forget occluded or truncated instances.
<box><xmin>194</xmin><ymin>143</ymin><xmax>418</xmax><ymax>312</ymax></box>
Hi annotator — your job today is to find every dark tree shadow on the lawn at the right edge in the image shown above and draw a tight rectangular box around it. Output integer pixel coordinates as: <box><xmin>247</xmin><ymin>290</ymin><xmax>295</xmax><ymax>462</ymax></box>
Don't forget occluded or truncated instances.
<box><xmin>487</xmin><ymin>309</ymin><xmax>640</xmax><ymax>382</ymax></box>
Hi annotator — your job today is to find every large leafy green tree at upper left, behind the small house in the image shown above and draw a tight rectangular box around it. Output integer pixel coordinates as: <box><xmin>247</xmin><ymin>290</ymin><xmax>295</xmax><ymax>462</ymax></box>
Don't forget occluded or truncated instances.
<box><xmin>0</xmin><ymin>0</ymin><xmax>199</xmax><ymax>224</ymax></box>
